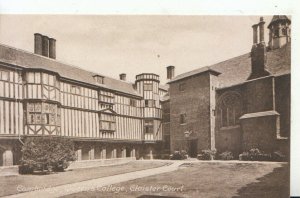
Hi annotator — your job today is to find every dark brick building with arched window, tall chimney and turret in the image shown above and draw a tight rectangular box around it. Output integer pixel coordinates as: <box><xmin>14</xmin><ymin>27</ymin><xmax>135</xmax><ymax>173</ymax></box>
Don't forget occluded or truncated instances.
<box><xmin>169</xmin><ymin>15</ymin><xmax>291</xmax><ymax>156</ymax></box>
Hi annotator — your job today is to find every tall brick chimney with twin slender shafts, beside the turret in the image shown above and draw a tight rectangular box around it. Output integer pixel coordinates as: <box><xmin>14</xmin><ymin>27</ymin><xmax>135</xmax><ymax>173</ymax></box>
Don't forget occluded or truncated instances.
<box><xmin>248</xmin><ymin>17</ymin><xmax>270</xmax><ymax>80</ymax></box>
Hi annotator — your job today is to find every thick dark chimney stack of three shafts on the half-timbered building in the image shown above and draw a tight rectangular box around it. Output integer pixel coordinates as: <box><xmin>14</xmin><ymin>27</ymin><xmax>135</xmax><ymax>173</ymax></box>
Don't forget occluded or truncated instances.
<box><xmin>34</xmin><ymin>33</ymin><xmax>56</xmax><ymax>59</ymax></box>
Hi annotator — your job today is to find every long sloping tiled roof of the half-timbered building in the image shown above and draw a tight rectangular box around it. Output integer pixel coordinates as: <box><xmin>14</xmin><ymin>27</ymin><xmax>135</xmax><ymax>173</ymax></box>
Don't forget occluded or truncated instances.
<box><xmin>0</xmin><ymin>44</ymin><xmax>140</xmax><ymax>96</ymax></box>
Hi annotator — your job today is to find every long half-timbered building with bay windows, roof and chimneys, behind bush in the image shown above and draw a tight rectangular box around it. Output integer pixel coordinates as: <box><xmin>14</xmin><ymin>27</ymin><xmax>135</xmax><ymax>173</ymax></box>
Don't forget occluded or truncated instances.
<box><xmin>0</xmin><ymin>33</ymin><xmax>167</xmax><ymax>166</ymax></box>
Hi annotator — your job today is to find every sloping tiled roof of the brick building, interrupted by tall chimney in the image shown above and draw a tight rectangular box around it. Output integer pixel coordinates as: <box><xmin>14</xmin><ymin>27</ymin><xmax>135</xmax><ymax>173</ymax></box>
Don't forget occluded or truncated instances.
<box><xmin>168</xmin><ymin>43</ymin><xmax>291</xmax><ymax>88</ymax></box>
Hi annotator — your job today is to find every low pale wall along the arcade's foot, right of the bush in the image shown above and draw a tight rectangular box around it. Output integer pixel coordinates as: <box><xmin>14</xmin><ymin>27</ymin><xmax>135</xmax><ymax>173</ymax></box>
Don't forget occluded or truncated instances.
<box><xmin>67</xmin><ymin>157</ymin><xmax>136</xmax><ymax>170</ymax></box>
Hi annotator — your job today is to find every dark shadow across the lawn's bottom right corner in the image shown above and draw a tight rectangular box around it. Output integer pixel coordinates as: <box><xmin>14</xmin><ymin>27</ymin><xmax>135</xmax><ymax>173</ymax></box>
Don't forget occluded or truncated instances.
<box><xmin>234</xmin><ymin>165</ymin><xmax>290</xmax><ymax>198</ymax></box>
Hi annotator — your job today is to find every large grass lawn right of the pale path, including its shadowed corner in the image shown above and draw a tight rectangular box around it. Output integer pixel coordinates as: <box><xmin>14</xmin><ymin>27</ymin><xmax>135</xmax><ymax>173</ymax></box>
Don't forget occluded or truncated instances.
<box><xmin>66</xmin><ymin>162</ymin><xmax>289</xmax><ymax>198</ymax></box>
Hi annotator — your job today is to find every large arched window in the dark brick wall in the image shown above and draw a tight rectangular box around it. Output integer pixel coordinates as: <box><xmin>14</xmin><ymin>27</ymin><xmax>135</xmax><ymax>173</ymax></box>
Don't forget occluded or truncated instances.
<box><xmin>217</xmin><ymin>91</ymin><xmax>242</xmax><ymax>127</ymax></box>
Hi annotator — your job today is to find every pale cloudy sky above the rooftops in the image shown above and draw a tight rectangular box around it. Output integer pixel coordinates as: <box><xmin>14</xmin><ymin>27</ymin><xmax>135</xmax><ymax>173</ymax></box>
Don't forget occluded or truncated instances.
<box><xmin>0</xmin><ymin>15</ymin><xmax>272</xmax><ymax>83</ymax></box>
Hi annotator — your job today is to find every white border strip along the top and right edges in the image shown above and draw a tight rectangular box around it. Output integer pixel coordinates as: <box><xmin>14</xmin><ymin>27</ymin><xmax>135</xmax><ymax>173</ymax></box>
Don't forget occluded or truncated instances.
<box><xmin>0</xmin><ymin>0</ymin><xmax>300</xmax><ymax>196</ymax></box>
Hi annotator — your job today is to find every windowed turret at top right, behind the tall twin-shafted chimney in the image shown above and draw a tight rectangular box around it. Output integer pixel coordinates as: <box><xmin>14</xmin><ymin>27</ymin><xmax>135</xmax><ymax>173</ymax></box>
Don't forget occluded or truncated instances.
<box><xmin>268</xmin><ymin>15</ymin><xmax>291</xmax><ymax>49</ymax></box>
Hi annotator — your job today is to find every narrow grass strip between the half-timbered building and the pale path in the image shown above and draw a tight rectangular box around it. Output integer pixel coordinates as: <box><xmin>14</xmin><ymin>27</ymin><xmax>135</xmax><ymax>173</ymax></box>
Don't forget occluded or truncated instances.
<box><xmin>0</xmin><ymin>161</ymin><xmax>168</xmax><ymax>197</ymax></box>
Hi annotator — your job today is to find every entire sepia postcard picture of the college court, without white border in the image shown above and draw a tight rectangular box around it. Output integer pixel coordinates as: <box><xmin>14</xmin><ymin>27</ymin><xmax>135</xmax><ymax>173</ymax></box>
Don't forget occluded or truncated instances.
<box><xmin>0</xmin><ymin>0</ymin><xmax>295</xmax><ymax>198</ymax></box>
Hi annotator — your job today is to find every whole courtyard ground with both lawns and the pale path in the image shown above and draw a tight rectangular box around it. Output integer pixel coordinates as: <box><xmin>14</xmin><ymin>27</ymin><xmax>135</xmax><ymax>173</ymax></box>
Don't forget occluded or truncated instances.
<box><xmin>0</xmin><ymin>160</ymin><xmax>289</xmax><ymax>198</ymax></box>
